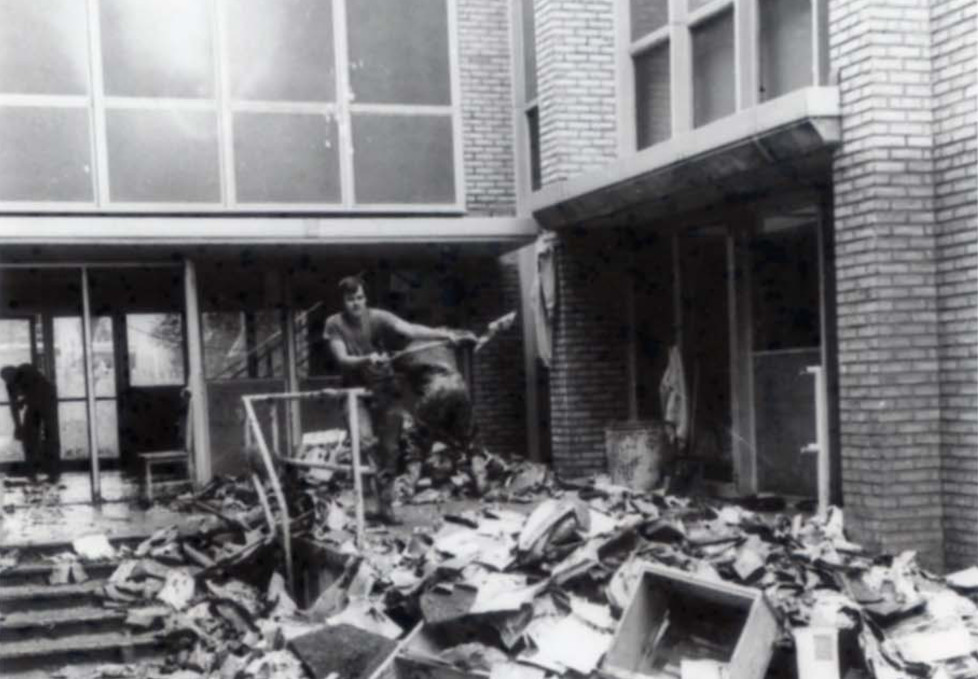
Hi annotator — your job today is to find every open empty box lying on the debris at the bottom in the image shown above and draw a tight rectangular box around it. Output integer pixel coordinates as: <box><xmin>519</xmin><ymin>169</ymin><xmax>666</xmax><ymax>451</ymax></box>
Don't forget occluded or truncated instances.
<box><xmin>600</xmin><ymin>565</ymin><xmax>778</xmax><ymax>679</ymax></box>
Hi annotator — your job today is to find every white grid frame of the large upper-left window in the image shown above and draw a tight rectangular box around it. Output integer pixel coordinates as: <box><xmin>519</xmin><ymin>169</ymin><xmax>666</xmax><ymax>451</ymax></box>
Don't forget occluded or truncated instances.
<box><xmin>0</xmin><ymin>0</ymin><xmax>466</xmax><ymax>214</ymax></box>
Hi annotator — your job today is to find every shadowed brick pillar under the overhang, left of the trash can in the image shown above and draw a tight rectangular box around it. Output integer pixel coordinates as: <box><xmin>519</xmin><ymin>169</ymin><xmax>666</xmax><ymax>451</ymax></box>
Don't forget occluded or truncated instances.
<box><xmin>550</xmin><ymin>233</ymin><xmax>628</xmax><ymax>478</ymax></box>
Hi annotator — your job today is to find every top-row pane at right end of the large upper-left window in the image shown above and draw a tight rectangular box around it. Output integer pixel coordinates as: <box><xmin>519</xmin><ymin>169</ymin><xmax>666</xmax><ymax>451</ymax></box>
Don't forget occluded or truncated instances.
<box><xmin>347</xmin><ymin>0</ymin><xmax>452</xmax><ymax>105</ymax></box>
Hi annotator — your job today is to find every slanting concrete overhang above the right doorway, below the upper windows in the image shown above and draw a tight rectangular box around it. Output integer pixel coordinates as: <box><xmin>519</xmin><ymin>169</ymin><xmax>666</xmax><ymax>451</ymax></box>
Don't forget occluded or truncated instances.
<box><xmin>530</xmin><ymin>87</ymin><xmax>842</xmax><ymax>229</ymax></box>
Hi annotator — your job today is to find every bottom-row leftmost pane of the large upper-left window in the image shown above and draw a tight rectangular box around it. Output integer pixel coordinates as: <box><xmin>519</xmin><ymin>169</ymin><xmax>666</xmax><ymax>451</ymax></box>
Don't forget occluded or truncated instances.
<box><xmin>0</xmin><ymin>107</ymin><xmax>93</xmax><ymax>202</ymax></box>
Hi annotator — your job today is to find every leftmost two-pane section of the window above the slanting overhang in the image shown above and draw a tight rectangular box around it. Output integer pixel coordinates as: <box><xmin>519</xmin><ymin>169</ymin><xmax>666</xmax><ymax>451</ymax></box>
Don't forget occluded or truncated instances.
<box><xmin>629</xmin><ymin>0</ymin><xmax>672</xmax><ymax>150</ymax></box>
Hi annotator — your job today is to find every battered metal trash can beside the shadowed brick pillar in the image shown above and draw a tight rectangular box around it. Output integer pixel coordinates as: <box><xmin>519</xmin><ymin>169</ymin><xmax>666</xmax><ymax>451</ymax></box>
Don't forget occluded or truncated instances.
<box><xmin>605</xmin><ymin>420</ymin><xmax>672</xmax><ymax>492</ymax></box>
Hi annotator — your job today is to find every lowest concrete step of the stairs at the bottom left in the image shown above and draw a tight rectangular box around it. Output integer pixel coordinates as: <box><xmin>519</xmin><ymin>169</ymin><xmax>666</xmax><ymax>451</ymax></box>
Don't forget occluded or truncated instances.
<box><xmin>0</xmin><ymin>632</ymin><xmax>165</xmax><ymax>676</ymax></box>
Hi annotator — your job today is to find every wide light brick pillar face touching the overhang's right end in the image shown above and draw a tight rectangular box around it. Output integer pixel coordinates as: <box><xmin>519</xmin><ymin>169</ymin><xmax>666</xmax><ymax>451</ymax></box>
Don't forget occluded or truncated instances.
<box><xmin>829</xmin><ymin>0</ymin><xmax>943</xmax><ymax>569</ymax></box>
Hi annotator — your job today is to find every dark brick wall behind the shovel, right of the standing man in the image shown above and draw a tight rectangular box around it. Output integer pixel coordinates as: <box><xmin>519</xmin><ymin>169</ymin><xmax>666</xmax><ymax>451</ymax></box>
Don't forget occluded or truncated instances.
<box><xmin>469</xmin><ymin>253</ymin><xmax>527</xmax><ymax>455</ymax></box>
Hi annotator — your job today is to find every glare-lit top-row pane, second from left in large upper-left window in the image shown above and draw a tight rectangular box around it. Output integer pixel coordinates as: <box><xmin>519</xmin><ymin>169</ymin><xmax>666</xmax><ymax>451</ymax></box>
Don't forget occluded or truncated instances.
<box><xmin>100</xmin><ymin>0</ymin><xmax>214</xmax><ymax>98</ymax></box>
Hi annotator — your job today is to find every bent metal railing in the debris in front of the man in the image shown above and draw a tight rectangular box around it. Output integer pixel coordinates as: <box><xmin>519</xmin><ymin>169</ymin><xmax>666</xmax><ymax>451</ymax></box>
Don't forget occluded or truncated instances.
<box><xmin>241</xmin><ymin>388</ymin><xmax>375</xmax><ymax>591</ymax></box>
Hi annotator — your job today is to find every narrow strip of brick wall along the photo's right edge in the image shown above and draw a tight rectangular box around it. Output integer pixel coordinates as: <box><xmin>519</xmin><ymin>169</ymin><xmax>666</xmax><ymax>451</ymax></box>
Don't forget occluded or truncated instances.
<box><xmin>931</xmin><ymin>0</ymin><xmax>978</xmax><ymax>568</ymax></box>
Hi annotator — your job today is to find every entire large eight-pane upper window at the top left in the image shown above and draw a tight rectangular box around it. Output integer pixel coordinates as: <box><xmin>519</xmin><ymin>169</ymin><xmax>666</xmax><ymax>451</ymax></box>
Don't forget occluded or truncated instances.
<box><xmin>0</xmin><ymin>0</ymin><xmax>464</xmax><ymax>211</ymax></box>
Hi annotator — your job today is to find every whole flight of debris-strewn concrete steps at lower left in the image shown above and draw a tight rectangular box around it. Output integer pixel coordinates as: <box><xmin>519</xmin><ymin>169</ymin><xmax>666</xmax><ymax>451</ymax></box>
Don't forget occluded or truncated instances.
<box><xmin>0</xmin><ymin>545</ymin><xmax>164</xmax><ymax>679</ymax></box>
